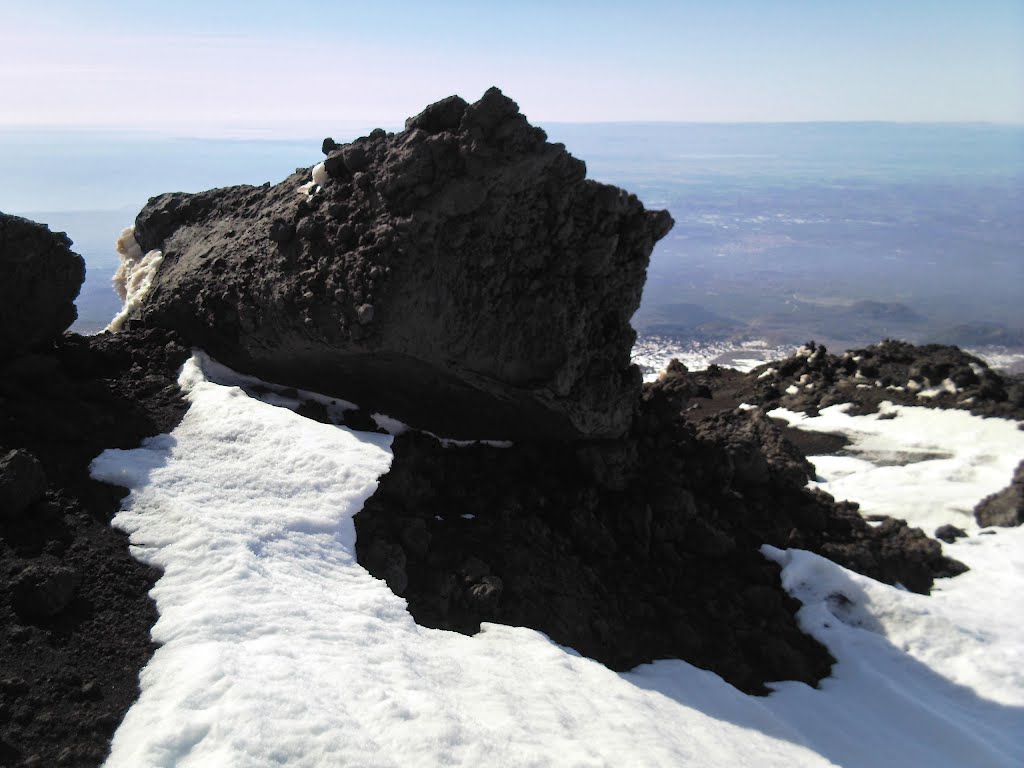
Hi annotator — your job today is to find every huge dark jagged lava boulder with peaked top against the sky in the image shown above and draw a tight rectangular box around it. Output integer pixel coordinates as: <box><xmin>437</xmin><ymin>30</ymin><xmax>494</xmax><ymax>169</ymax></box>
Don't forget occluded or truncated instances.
<box><xmin>117</xmin><ymin>88</ymin><xmax>673</xmax><ymax>437</ymax></box>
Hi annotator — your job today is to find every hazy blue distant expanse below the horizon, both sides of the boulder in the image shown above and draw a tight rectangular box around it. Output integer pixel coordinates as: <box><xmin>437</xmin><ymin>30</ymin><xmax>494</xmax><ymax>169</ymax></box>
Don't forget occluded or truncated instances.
<box><xmin>0</xmin><ymin>123</ymin><xmax>1024</xmax><ymax>370</ymax></box>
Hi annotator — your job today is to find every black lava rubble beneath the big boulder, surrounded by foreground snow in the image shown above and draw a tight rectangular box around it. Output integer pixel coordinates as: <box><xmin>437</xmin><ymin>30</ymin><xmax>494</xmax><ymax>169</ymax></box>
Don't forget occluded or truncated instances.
<box><xmin>355</xmin><ymin>365</ymin><xmax>966</xmax><ymax>693</ymax></box>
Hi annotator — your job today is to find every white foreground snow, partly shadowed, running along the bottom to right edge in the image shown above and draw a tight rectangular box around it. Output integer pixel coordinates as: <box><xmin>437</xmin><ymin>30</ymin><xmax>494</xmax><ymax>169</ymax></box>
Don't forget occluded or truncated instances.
<box><xmin>93</xmin><ymin>353</ymin><xmax>1024</xmax><ymax>768</ymax></box>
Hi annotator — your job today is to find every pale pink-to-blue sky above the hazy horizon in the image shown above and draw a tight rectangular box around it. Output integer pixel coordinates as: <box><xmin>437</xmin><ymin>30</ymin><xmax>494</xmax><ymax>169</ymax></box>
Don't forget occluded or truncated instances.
<box><xmin>0</xmin><ymin>0</ymin><xmax>1024</xmax><ymax>135</ymax></box>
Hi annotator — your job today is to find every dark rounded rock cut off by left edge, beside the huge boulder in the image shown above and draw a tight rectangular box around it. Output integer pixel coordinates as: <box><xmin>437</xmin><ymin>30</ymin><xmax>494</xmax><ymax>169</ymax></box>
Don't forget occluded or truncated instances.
<box><xmin>0</xmin><ymin>212</ymin><xmax>85</xmax><ymax>356</ymax></box>
